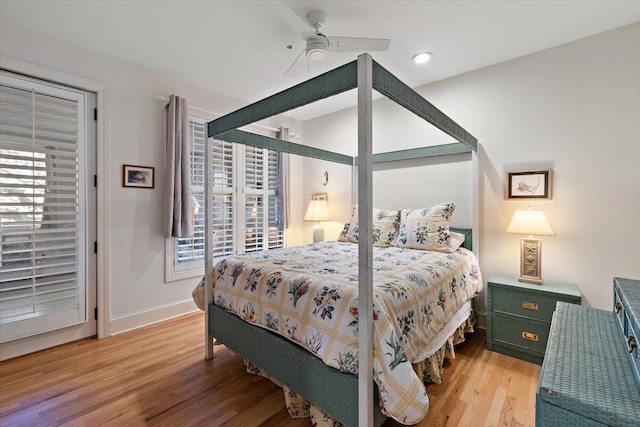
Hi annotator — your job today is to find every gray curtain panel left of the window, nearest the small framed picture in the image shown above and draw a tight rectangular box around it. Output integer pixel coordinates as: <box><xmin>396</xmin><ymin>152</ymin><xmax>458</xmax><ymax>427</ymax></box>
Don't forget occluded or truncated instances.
<box><xmin>165</xmin><ymin>95</ymin><xmax>193</xmax><ymax>237</ymax></box>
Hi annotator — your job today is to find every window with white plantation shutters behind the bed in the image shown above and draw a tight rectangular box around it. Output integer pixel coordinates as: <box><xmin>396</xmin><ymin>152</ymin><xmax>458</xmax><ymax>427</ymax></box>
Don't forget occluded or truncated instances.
<box><xmin>166</xmin><ymin>116</ymin><xmax>284</xmax><ymax>281</ymax></box>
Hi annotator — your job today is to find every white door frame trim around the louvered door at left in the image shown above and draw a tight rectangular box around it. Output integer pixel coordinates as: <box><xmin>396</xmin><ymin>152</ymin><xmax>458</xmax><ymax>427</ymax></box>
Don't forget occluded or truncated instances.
<box><xmin>0</xmin><ymin>55</ymin><xmax>110</xmax><ymax>338</ymax></box>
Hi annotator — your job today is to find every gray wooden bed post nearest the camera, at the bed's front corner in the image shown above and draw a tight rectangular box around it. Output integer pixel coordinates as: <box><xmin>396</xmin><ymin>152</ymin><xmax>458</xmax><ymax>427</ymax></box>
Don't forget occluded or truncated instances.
<box><xmin>358</xmin><ymin>53</ymin><xmax>373</xmax><ymax>427</ymax></box>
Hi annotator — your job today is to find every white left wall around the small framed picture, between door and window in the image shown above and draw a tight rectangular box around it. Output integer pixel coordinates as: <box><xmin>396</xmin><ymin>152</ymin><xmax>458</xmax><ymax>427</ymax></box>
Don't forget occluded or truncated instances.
<box><xmin>0</xmin><ymin>24</ymin><xmax>303</xmax><ymax>333</ymax></box>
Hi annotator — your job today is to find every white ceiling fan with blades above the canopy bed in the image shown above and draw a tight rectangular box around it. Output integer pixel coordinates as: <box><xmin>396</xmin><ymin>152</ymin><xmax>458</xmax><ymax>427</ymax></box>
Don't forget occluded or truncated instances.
<box><xmin>269</xmin><ymin>1</ymin><xmax>391</xmax><ymax>75</ymax></box>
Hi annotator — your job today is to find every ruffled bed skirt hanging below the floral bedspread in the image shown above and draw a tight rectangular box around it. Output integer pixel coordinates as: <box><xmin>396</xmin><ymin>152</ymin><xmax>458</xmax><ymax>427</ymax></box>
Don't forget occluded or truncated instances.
<box><xmin>244</xmin><ymin>308</ymin><xmax>476</xmax><ymax>427</ymax></box>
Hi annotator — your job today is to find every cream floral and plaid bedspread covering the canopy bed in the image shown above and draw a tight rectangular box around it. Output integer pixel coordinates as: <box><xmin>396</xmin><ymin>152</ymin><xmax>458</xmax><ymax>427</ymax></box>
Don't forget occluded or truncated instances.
<box><xmin>205</xmin><ymin>242</ymin><xmax>482</xmax><ymax>424</ymax></box>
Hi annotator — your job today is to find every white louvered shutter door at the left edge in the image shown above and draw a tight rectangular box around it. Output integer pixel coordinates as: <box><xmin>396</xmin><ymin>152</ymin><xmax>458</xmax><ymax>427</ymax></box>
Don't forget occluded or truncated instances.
<box><xmin>0</xmin><ymin>72</ymin><xmax>96</xmax><ymax>358</ymax></box>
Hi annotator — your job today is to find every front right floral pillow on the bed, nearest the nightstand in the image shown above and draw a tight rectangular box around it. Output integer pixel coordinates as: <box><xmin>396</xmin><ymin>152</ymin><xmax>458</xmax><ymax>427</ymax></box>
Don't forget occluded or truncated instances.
<box><xmin>396</xmin><ymin>202</ymin><xmax>456</xmax><ymax>252</ymax></box>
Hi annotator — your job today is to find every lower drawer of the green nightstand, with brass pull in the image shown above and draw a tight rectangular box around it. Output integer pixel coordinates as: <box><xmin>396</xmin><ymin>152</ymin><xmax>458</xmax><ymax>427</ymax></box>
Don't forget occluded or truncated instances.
<box><xmin>493</xmin><ymin>316</ymin><xmax>549</xmax><ymax>357</ymax></box>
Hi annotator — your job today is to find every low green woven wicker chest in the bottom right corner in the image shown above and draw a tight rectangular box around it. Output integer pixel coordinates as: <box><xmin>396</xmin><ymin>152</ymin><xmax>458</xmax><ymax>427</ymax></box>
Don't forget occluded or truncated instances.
<box><xmin>536</xmin><ymin>302</ymin><xmax>640</xmax><ymax>427</ymax></box>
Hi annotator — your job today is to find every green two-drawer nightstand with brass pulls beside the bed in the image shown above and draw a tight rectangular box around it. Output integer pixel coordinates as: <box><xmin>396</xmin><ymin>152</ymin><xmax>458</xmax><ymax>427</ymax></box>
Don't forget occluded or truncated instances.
<box><xmin>487</xmin><ymin>274</ymin><xmax>582</xmax><ymax>365</ymax></box>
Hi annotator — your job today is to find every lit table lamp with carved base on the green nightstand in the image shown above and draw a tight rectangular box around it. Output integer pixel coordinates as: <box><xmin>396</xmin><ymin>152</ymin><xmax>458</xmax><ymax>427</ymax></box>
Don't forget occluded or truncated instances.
<box><xmin>507</xmin><ymin>207</ymin><xmax>556</xmax><ymax>285</ymax></box>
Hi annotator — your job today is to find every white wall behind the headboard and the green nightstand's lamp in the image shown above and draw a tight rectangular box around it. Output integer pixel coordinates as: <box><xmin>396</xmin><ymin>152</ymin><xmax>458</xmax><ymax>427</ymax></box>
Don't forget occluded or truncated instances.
<box><xmin>304</xmin><ymin>23</ymin><xmax>640</xmax><ymax>316</ymax></box>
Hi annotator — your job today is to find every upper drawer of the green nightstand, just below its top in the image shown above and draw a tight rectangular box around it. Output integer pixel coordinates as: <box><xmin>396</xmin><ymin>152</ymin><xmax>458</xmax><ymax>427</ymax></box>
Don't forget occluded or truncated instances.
<box><xmin>493</xmin><ymin>288</ymin><xmax>562</xmax><ymax>324</ymax></box>
